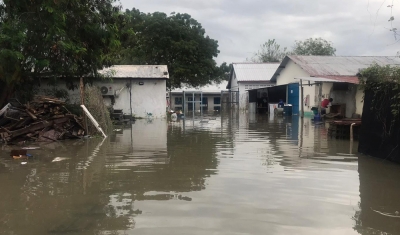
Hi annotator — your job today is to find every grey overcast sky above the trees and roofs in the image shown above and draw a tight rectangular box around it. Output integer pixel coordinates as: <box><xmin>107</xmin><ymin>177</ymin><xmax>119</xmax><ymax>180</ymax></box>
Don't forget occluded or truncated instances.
<box><xmin>120</xmin><ymin>0</ymin><xmax>400</xmax><ymax>63</ymax></box>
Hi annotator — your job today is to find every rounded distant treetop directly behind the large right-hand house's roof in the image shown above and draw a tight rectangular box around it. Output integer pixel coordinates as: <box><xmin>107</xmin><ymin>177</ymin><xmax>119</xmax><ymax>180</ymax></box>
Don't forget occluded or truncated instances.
<box><xmin>292</xmin><ymin>38</ymin><xmax>336</xmax><ymax>56</ymax></box>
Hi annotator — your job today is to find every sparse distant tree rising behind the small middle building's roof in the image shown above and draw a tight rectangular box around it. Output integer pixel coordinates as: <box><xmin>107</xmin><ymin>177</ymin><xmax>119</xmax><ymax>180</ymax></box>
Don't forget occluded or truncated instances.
<box><xmin>251</xmin><ymin>39</ymin><xmax>289</xmax><ymax>63</ymax></box>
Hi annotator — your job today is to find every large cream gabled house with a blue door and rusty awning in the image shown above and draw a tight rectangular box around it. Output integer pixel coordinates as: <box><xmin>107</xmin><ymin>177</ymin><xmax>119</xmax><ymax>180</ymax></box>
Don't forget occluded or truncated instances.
<box><xmin>271</xmin><ymin>55</ymin><xmax>400</xmax><ymax>117</ymax></box>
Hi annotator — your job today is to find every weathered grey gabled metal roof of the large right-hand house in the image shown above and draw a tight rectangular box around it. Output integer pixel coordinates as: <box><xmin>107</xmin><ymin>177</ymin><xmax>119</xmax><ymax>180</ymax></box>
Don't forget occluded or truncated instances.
<box><xmin>271</xmin><ymin>55</ymin><xmax>400</xmax><ymax>83</ymax></box>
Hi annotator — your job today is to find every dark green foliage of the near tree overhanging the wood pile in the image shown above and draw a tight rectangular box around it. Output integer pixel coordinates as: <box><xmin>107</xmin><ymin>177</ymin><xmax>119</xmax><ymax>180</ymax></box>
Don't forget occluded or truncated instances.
<box><xmin>0</xmin><ymin>0</ymin><xmax>120</xmax><ymax>104</ymax></box>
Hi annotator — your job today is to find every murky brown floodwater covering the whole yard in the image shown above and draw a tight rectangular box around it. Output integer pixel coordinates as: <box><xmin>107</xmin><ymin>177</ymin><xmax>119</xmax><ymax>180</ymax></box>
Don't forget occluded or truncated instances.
<box><xmin>0</xmin><ymin>113</ymin><xmax>400</xmax><ymax>235</ymax></box>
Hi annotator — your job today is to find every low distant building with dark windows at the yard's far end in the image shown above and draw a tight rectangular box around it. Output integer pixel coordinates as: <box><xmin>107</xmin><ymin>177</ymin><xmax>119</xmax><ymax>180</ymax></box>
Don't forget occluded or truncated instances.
<box><xmin>167</xmin><ymin>81</ymin><xmax>228</xmax><ymax>112</ymax></box>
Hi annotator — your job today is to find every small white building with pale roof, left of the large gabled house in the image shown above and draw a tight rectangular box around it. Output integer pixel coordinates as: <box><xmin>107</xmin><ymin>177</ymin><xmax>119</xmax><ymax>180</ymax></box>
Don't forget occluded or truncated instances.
<box><xmin>226</xmin><ymin>63</ymin><xmax>279</xmax><ymax>110</ymax></box>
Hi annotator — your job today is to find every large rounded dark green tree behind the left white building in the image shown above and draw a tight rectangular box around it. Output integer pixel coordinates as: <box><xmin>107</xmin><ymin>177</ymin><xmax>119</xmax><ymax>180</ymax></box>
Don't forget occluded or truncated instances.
<box><xmin>116</xmin><ymin>9</ymin><xmax>222</xmax><ymax>88</ymax></box>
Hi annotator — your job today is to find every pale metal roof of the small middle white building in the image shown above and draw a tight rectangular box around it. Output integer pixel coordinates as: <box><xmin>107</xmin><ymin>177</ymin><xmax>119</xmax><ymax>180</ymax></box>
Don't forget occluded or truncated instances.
<box><xmin>233</xmin><ymin>63</ymin><xmax>279</xmax><ymax>82</ymax></box>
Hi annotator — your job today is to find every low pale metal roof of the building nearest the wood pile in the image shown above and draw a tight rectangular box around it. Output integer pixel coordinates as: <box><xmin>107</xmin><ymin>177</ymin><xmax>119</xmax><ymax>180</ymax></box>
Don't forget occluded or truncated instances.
<box><xmin>99</xmin><ymin>65</ymin><xmax>169</xmax><ymax>79</ymax></box>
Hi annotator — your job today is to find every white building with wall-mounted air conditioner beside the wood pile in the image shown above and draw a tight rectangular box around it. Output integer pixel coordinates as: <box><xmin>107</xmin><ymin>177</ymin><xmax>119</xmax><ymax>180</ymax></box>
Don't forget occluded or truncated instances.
<box><xmin>40</xmin><ymin>65</ymin><xmax>169</xmax><ymax>118</ymax></box>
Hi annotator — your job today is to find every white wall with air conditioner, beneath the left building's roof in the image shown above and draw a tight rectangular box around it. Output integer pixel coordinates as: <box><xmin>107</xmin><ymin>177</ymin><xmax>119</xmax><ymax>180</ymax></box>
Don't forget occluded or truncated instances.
<box><xmin>39</xmin><ymin>79</ymin><xmax>167</xmax><ymax>118</ymax></box>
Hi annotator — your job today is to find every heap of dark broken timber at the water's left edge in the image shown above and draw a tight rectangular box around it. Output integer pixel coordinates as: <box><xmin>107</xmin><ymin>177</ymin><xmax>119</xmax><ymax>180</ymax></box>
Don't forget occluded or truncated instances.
<box><xmin>0</xmin><ymin>96</ymin><xmax>85</xmax><ymax>143</ymax></box>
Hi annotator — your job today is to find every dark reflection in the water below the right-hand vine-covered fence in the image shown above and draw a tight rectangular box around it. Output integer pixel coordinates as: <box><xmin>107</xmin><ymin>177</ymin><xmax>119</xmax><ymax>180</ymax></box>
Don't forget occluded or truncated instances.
<box><xmin>354</xmin><ymin>156</ymin><xmax>400</xmax><ymax>235</ymax></box>
